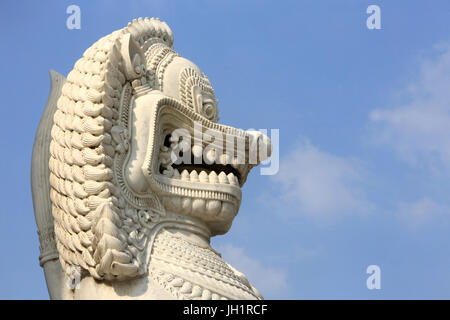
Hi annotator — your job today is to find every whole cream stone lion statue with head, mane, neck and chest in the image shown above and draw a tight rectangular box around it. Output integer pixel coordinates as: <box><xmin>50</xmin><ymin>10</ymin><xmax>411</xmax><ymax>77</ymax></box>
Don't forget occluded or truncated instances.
<box><xmin>31</xmin><ymin>18</ymin><xmax>271</xmax><ymax>300</ymax></box>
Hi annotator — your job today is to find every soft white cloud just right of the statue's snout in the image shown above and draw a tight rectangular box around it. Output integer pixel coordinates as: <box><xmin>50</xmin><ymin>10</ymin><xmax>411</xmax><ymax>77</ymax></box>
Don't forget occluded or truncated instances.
<box><xmin>273</xmin><ymin>139</ymin><xmax>372</xmax><ymax>219</ymax></box>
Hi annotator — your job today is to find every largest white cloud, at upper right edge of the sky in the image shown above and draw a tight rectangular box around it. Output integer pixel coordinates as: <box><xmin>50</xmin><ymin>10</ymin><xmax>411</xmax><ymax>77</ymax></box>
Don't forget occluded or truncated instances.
<box><xmin>370</xmin><ymin>45</ymin><xmax>450</xmax><ymax>173</ymax></box>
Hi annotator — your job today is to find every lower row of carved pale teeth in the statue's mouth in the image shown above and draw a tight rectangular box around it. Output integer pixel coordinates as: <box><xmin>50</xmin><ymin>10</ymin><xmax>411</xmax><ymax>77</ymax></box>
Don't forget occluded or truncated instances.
<box><xmin>163</xmin><ymin>166</ymin><xmax>239</xmax><ymax>186</ymax></box>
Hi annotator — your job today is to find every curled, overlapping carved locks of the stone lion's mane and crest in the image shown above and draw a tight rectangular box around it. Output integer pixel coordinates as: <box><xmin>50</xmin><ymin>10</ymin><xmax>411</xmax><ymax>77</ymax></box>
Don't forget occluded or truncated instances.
<box><xmin>49</xmin><ymin>18</ymin><xmax>173</xmax><ymax>280</ymax></box>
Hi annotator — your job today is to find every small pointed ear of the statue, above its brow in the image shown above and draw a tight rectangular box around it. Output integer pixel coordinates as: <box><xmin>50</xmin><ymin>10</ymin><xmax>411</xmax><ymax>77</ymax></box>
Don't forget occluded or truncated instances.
<box><xmin>120</xmin><ymin>34</ymin><xmax>146</xmax><ymax>81</ymax></box>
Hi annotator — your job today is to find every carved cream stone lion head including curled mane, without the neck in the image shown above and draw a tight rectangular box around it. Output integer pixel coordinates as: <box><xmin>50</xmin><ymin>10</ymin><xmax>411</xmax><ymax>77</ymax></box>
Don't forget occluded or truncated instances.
<box><xmin>49</xmin><ymin>18</ymin><xmax>270</xmax><ymax>280</ymax></box>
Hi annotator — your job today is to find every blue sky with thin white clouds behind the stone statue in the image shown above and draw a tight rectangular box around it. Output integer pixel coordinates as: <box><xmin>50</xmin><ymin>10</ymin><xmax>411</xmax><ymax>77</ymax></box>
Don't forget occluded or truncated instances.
<box><xmin>0</xmin><ymin>0</ymin><xmax>450</xmax><ymax>299</ymax></box>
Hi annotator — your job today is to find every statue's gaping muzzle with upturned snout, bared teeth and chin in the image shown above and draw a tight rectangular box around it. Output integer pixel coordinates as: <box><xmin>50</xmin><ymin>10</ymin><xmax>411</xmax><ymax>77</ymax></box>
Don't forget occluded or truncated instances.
<box><xmin>127</xmin><ymin>96</ymin><xmax>270</xmax><ymax>235</ymax></box>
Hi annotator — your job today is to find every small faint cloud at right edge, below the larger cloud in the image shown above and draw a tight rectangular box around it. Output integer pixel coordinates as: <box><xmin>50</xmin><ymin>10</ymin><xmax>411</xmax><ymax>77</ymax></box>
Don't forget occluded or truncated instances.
<box><xmin>396</xmin><ymin>197</ymin><xmax>450</xmax><ymax>229</ymax></box>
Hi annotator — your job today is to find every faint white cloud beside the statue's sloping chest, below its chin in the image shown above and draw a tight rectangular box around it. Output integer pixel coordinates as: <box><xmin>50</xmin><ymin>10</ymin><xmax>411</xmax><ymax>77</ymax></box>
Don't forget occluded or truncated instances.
<box><xmin>217</xmin><ymin>244</ymin><xmax>288</xmax><ymax>299</ymax></box>
